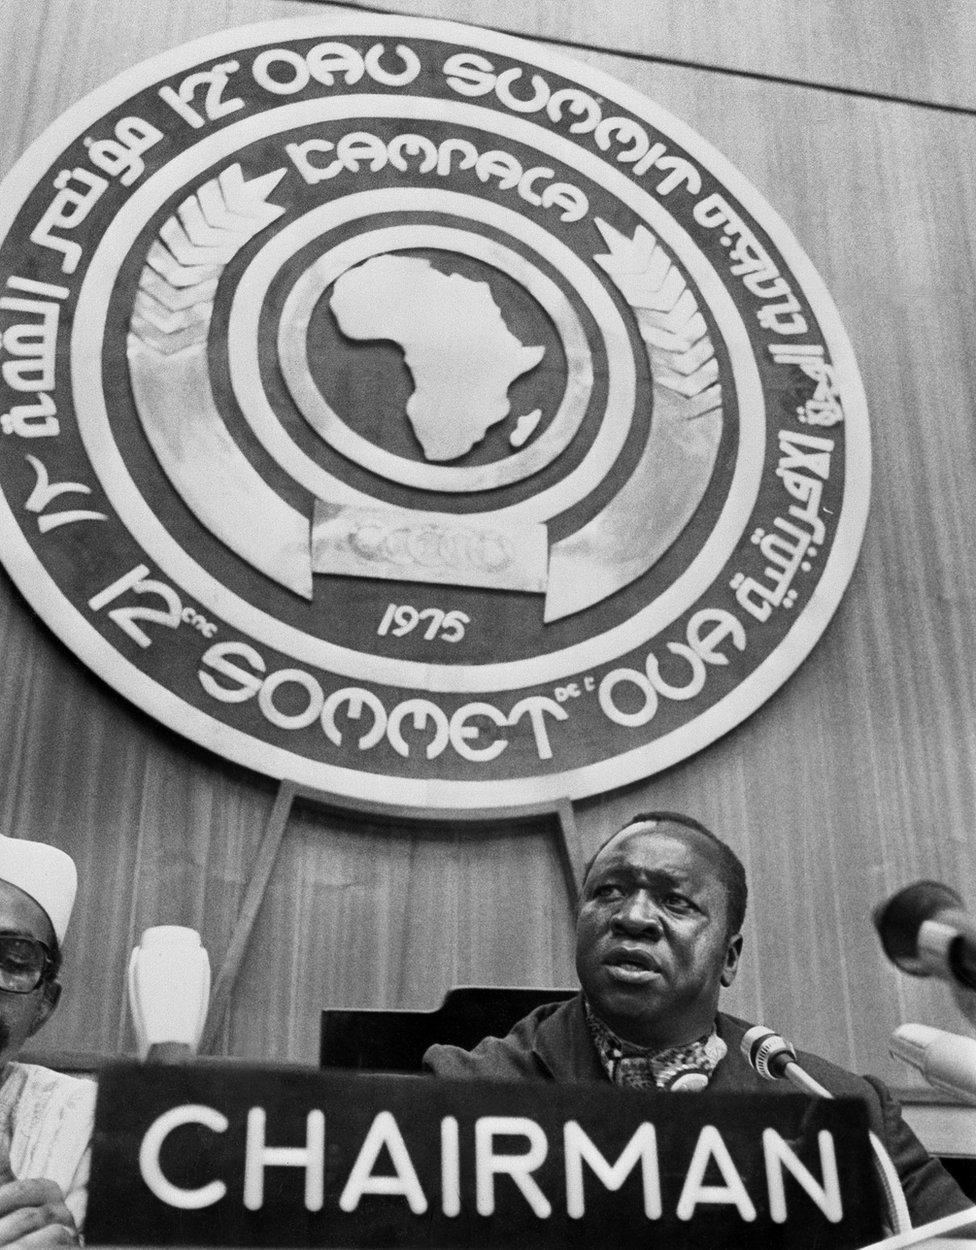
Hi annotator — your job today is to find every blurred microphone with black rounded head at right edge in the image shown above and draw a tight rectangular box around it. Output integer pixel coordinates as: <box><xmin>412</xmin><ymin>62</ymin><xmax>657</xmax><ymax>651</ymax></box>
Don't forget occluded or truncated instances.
<box><xmin>872</xmin><ymin>881</ymin><xmax>976</xmax><ymax>990</ymax></box>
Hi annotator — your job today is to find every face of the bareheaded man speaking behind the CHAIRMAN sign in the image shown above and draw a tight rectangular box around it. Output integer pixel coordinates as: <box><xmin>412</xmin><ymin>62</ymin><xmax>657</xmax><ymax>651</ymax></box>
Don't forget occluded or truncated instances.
<box><xmin>576</xmin><ymin>823</ymin><xmax>742</xmax><ymax>1050</ymax></box>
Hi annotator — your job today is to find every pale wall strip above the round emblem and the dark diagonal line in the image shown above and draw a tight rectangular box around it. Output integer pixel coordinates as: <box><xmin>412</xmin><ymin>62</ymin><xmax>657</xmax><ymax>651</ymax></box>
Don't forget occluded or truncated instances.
<box><xmin>7</xmin><ymin>0</ymin><xmax>976</xmax><ymax>168</ymax></box>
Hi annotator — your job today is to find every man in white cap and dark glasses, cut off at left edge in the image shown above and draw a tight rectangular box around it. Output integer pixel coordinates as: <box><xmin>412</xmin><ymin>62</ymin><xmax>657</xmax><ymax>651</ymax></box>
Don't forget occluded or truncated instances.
<box><xmin>0</xmin><ymin>836</ymin><xmax>95</xmax><ymax>1246</ymax></box>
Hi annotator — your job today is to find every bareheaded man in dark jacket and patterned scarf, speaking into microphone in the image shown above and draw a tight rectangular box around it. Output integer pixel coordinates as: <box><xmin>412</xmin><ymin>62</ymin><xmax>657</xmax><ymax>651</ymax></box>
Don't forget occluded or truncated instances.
<box><xmin>424</xmin><ymin>813</ymin><xmax>971</xmax><ymax>1225</ymax></box>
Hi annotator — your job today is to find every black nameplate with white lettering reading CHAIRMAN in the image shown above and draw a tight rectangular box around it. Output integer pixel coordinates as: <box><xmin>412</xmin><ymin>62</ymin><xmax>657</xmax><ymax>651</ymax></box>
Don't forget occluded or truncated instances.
<box><xmin>85</xmin><ymin>1064</ymin><xmax>880</xmax><ymax>1250</ymax></box>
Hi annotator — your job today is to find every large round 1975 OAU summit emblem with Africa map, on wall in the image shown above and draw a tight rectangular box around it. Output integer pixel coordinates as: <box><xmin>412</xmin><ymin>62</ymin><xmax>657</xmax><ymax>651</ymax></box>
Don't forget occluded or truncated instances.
<box><xmin>0</xmin><ymin>15</ymin><xmax>870</xmax><ymax>809</ymax></box>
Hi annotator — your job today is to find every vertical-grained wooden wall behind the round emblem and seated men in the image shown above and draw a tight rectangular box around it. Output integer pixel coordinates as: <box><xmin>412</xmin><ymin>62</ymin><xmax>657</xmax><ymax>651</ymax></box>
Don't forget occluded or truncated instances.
<box><xmin>0</xmin><ymin>0</ymin><xmax>976</xmax><ymax>1085</ymax></box>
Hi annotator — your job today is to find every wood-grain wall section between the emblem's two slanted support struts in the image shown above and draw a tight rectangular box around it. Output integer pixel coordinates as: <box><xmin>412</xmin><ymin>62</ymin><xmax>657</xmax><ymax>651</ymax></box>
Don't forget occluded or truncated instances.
<box><xmin>225</xmin><ymin>806</ymin><xmax>574</xmax><ymax>1060</ymax></box>
